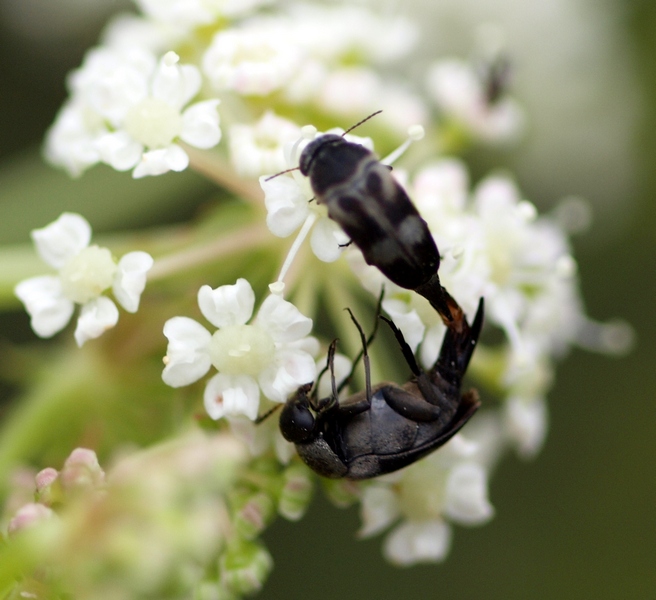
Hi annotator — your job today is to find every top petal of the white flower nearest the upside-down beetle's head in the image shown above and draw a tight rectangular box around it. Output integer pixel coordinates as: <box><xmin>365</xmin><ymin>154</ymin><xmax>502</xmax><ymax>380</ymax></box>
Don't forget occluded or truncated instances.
<box><xmin>198</xmin><ymin>278</ymin><xmax>255</xmax><ymax>327</ymax></box>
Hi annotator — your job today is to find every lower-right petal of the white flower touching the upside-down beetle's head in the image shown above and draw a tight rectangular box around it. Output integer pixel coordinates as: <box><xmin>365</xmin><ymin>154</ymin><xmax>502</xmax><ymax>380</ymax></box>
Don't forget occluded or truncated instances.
<box><xmin>258</xmin><ymin>350</ymin><xmax>317</xmax><ymax>402</ymax></box>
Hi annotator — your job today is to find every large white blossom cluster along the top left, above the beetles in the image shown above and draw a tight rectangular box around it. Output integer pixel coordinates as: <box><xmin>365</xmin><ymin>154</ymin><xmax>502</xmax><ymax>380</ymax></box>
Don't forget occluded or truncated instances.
<box><xmin>45</xmin><ymin>0</ymin><xmax>428</xmax><ymax>183</ymax></box>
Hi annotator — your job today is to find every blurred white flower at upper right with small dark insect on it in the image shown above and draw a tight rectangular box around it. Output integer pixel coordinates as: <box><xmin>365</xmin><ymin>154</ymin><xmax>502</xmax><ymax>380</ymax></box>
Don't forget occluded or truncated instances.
<box><xmin>427</xmin><ymin>59</ymin><xmax>524</xmax><ymax>142</ymax></box>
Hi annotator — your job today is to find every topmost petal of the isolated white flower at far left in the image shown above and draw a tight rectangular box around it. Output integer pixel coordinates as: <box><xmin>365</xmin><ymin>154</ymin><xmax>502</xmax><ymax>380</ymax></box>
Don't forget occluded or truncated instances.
<box><xmin>31</xmin><ymin>213</ymin><xmax>91</xmax><ymax>269</ymax></box>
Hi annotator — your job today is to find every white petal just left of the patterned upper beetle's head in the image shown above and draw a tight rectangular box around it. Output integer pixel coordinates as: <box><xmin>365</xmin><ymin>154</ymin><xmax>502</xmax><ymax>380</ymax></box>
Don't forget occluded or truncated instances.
<box><xmin>260</xmin><ymin>175</ymin><xmax>310</xmax><ymax>237</ymax></box>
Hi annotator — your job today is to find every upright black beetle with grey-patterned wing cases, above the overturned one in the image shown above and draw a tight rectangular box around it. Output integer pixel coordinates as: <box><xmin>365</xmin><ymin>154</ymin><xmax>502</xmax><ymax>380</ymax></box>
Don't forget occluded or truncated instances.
<box><xmin>299</xmin><ymin>118</ymin><xmax>452</xmax><ymax>323</ymax></box>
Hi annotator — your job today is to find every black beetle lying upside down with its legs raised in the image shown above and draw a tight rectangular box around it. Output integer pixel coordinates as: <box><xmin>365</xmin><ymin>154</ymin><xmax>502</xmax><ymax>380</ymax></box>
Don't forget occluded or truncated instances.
<box><xmin>280</xmin><ymin>298</ymin><xmax>484</xmax><ymax>480</ymax></box>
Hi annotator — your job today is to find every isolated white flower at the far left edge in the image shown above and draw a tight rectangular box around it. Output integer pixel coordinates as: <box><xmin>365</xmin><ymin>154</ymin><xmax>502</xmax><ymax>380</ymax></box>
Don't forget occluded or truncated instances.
<box><xmin>15</xmin><ymin>213</ymin><xmax>153</xmax><ymax>346</ymax></box>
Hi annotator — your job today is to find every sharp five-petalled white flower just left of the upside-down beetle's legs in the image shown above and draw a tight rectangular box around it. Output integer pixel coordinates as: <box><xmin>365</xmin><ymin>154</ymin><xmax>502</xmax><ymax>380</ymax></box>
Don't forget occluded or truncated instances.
<box><xmin>162</xmin><ymin>279</ymin><xmax>316</xmax><ymax>419</ymax></box>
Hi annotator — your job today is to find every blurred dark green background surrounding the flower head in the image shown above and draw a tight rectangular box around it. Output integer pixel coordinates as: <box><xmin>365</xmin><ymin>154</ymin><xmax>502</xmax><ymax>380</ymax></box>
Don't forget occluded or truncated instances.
<box><xmin>0</xmin><ymin>0</ymin><xmax>656</xmax><ymax>600</ymax></box>
